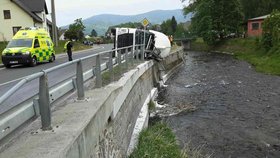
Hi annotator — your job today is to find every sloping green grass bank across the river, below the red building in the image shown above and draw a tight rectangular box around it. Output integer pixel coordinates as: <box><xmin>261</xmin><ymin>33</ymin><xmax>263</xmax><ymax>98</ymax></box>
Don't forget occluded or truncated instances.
<box><xmin>192</xmin><ymin>38</ymin><xmax>280</xmax><ymax>75</ymax></box>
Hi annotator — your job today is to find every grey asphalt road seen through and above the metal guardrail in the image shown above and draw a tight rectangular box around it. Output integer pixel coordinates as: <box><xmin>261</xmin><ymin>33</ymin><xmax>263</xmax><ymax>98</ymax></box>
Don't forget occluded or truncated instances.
<box><xmin>0</xmin><ymin>44</ymin><xmax>113</xmax><ymax>114</ymax></box>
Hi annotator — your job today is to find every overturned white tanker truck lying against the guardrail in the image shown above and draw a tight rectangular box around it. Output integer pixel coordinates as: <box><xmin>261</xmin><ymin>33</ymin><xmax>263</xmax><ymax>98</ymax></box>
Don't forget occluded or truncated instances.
<box><xmin>111</xmin><ymin>28</ymin><xmax>171</xmax><ymax>61</ymax></box>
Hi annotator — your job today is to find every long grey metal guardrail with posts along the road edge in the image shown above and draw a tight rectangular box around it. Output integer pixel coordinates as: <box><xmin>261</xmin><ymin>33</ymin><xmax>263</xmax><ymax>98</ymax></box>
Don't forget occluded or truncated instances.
<box><xmin>0</xmin><ymin>44</ymin><xmax>144</xmax><ymax>140</ymax></box>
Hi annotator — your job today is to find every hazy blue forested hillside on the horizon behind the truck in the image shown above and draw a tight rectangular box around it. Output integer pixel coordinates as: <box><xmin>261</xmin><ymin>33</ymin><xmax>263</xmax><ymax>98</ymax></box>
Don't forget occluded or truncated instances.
<box><xmin>63</xmin><ymin>9</ymin><xmax>191</xmax><ymax>35</ymax></box>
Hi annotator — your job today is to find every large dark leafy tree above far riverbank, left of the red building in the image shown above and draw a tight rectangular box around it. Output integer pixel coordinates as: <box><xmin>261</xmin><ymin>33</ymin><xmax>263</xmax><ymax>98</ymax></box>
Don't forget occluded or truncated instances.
<box><xmin>183</xmin><ymin>0</ymin><xmax>243</xmax><ymax>45</ymax></box>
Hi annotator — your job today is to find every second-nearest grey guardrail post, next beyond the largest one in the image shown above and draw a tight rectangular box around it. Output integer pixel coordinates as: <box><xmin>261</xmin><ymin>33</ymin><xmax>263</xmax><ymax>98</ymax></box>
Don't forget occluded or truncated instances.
<box><xmin>76</xmin><ymin>59</ymin><xmax>85</xmax><ymax>100</ymax></box>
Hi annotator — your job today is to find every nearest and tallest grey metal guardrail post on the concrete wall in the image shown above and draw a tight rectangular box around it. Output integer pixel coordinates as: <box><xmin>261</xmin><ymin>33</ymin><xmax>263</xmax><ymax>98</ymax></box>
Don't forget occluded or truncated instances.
<box><xmin>39</xmin><ymin>72</ymin><xmax>52</xmax><ymax>131</ymax></box>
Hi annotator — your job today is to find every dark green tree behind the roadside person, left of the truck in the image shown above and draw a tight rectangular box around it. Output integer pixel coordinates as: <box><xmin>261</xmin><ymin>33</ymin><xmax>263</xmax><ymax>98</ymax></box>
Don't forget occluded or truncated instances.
<box><xmin>65</xmin><ymin>18</ymin><xmax>85</xmax><ymax>41</ymax></box>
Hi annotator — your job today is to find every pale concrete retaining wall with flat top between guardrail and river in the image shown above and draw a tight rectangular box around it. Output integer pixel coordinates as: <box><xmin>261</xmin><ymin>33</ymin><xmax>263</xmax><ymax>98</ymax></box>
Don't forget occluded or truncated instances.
<box><xmin>0</xmin><ymin>47</ymin><xmax>182</xmax><ymax>158</ymax></box>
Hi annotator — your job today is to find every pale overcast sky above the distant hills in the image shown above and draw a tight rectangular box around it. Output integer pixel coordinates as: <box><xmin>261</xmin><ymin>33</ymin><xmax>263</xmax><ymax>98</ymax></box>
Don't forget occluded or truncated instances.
<box><xmin>46</xmin><ymin>0</ymin><xmax>186</xmax><ymax>26</ymax></box>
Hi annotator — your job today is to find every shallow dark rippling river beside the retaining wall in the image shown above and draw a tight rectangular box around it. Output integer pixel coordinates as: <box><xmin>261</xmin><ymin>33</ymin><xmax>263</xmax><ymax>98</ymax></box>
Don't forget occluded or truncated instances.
<box><xmin>155</xmin><ymin>52</ymin><xmax>280</xmax><ymax>158</ymax></box>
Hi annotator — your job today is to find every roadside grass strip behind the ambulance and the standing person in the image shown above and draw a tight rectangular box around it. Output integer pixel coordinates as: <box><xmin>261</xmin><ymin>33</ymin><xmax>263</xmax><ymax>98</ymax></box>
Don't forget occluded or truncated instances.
<box><xmin>0</xmin><ymin>41</ymin><xmax>91</xmax><ymax>63</ymax></box>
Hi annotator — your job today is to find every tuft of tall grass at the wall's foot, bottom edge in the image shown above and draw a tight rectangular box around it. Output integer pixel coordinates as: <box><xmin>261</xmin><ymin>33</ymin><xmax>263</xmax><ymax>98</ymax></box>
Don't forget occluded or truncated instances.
<box><xmin>129</xmin><ymin>122</ymin><xmax>207</xmax><ymax>158</ymax></box>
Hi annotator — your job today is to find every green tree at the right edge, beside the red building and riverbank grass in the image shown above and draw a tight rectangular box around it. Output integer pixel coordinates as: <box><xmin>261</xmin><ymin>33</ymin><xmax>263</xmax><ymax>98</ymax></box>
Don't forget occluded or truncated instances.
<box><xmin>262</xmin><ymin>10</ymin><xmax>280</xmax><ymax>50</ymax></box>
